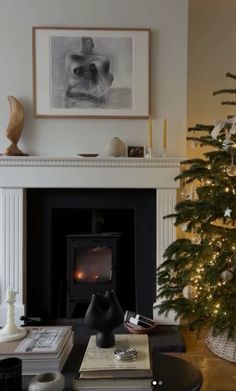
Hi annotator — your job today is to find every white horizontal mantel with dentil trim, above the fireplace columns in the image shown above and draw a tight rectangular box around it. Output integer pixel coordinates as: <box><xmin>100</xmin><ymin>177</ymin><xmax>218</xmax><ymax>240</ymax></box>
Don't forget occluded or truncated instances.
<box><xmin>0</xmin><ymin>156</ymin><xmax>180</xmax><ymax>188</ymax></box>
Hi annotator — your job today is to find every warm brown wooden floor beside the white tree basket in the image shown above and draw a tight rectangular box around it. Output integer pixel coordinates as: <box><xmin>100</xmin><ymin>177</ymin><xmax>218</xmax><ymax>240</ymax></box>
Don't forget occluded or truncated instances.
<box><xmin>169</xmin><ymin>330</ymin><xmax>236</xmax><ymax>391</ymax></box>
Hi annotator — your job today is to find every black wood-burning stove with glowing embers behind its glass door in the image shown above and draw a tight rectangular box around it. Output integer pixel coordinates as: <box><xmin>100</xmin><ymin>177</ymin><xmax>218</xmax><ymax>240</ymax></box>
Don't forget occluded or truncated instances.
<box><xmin>67</xmin><ymin>232</ymin><xmax>121</xmax><ymax>318</ymax></box>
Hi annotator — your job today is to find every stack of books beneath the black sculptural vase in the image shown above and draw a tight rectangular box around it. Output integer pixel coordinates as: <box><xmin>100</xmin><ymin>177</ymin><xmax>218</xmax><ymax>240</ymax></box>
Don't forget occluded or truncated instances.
<box><xmin>73</xmin><ymin>334</ymin><xmax>152</xmax><ymax>391</ymax></box>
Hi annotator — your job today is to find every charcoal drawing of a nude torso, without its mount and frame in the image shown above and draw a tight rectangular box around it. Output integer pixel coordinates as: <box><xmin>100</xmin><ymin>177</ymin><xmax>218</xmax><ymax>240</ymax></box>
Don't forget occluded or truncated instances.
<box><xmin>50</xmin><ymin>36</ymin><xmax>133</xmax><ymax>110</ymax></box>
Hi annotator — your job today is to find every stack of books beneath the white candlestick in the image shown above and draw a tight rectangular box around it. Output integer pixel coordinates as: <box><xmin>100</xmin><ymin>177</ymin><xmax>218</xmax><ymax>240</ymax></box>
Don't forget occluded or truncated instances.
<box><xmin>0</xmin><ymin>326</ymin><xmax>74</xmax><ymax>375</ymax></box>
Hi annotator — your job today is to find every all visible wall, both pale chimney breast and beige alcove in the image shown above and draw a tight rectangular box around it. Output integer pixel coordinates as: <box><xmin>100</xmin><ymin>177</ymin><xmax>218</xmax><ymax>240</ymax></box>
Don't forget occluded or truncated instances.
<box><xmin>0</xmin><ymin>0</ymin><xmax>236</xmax><ymax>156</ymax></box>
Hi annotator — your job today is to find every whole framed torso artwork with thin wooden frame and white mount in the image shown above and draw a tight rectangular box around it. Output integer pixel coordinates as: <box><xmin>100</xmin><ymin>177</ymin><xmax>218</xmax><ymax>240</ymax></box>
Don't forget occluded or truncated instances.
<box><xmin>32</xmin><ymin>27</ymin><xmax>151</xmax><ymax>118</ymax></box>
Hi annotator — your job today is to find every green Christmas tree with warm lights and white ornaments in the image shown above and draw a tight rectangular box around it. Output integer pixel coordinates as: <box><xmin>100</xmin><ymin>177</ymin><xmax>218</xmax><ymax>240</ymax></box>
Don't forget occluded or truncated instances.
<box><xmin>157</xmin><ymin>73</ymin><xmax>236</xmax><ymax>339</ymax></box>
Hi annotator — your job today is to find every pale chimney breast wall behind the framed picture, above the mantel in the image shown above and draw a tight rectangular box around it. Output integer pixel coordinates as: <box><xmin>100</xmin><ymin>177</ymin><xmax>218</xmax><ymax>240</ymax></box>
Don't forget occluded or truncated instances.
<box><xmin>0</xmin><ymin>0</ymin><xmax>188</xmax><ymax>157</ymax></box>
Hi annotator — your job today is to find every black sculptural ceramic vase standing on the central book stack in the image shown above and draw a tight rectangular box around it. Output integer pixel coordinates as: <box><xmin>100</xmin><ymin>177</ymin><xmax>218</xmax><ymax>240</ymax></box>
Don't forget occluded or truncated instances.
<box><xmin>84</xmin><ymin>290</ymin><xmax>124</xmax><ymax>348</ymax></box>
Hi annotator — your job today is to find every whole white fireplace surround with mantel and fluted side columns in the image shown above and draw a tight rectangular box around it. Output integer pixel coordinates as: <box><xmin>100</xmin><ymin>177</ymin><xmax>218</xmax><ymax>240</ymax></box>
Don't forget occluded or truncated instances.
<box><xmin>0</xmin><ymin>156</ymin><xmax>183</xmax><ymax>326</ymax></box>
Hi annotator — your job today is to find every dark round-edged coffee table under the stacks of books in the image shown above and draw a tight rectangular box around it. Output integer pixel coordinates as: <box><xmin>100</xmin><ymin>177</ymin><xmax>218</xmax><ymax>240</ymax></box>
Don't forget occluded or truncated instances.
<box><xmin>23</xmin><ymin>327</ymin><xmax>203</xmax><ymax>391</ymax></box>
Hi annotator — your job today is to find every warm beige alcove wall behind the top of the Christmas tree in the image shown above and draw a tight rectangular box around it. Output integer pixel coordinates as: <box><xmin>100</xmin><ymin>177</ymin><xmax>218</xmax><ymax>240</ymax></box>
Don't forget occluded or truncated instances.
<box><xmin>187</xmin><ymin>0</ymin><xmax>236</xmax><ymax>126</ymax></box>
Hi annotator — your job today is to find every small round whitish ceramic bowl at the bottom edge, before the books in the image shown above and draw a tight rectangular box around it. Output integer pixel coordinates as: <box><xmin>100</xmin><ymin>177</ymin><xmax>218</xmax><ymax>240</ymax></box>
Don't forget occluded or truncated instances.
<box><xmin>28</xmin><ymin>372</ymin><xmax>65</xmax><ymax>391</ymax></box>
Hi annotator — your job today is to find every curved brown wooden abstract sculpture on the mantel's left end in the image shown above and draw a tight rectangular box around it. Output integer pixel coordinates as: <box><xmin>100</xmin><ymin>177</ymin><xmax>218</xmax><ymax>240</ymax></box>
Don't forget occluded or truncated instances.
<box><xmin>3</xmin><ymin>96</ymin><xmax>26</xmax><ymax>156</ymax></box>
